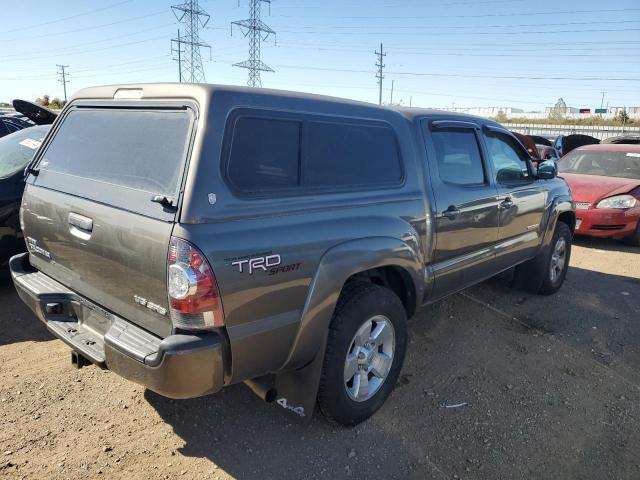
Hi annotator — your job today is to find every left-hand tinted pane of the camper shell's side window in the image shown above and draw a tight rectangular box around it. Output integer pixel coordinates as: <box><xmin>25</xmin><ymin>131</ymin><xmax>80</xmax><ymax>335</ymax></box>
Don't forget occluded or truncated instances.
<box><xmin>227</xmin><ymin>117</ymin><xmax>301</xmax><ymax>192</ymax></box>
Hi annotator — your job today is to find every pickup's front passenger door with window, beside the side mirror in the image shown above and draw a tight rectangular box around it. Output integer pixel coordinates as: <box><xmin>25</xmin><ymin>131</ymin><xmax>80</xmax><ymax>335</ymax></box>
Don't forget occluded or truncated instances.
<box><xmin>483</xmin><ymin>127</ymin><xmax>547</xmax><ymax>268</ymax></box>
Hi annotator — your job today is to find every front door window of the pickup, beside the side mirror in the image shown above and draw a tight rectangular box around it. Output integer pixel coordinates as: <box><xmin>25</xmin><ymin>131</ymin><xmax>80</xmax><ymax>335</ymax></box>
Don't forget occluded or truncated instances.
<box><xmin>485</xmin><ymin>132</ymin><xmax>532</xmax><ymax>183</ymax></box>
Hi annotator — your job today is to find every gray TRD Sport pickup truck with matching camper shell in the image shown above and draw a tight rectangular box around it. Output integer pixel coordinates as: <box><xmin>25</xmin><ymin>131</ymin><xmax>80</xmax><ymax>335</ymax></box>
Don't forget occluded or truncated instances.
<box><xmin>10</xmin><ymin>84</ymin><xmax>575</xmax><ymax>425</ymax></box>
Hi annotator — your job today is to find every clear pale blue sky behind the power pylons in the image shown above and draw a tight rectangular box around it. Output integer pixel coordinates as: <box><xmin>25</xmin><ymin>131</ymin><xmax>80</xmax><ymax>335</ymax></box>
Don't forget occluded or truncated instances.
<box><xmin>0</xmin><ymin>0</ymin><xmax>640</xmax><ymax>111</ymax></box>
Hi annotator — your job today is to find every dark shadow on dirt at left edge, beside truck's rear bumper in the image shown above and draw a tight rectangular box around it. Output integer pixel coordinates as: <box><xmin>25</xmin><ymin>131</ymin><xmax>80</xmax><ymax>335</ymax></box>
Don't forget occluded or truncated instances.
<box><xmin>0</xmin><ymin>277</ymin><xmax>54</xmax><ymax>346</ymax></box>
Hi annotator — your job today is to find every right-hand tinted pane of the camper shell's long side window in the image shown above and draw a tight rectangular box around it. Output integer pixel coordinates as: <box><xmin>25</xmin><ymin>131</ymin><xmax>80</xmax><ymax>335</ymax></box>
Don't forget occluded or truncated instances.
<box><xmin>302</xmin><ymin>121</ymin><xmax>402</xmax><ymax>187</ymax></box>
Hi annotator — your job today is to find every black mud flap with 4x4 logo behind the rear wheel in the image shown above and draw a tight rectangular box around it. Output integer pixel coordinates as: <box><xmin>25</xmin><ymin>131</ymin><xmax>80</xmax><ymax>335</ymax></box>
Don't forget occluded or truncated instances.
<box><xmin>276</xmin><ymin>335</ymin><xmax>327</xmax><ymax>423</ymax></box>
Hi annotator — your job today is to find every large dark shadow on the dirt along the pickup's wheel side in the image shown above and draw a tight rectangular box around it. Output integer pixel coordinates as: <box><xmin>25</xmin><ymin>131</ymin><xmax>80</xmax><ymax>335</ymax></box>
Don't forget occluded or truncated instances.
<box><xmin>145</xmin><ymin>268</ymin><xmax>640</xmax><ymax>479</ymax></box>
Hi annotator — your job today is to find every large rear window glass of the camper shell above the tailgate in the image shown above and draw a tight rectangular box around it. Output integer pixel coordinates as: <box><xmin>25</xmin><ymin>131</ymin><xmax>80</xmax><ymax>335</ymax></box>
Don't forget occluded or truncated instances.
<box><xmin>38</xmin><ymin>108</ymin><xmax>192</xmax><ymax>195</ymax></box>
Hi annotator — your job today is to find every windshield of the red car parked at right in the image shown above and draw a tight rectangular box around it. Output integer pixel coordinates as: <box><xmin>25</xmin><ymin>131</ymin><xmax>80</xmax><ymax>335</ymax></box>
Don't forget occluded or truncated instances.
<box><xmin>558</xmin><ymin>150</ymin><xmax>640</xmax><ymax>180</ymax></box>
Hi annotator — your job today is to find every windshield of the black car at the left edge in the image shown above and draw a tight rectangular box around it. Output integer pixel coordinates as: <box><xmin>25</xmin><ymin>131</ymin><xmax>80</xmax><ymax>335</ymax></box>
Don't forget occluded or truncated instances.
<box><xmin>0</xmin><ymin>125</ymin><xmax>49</xmax><ymax>178</ymax></box>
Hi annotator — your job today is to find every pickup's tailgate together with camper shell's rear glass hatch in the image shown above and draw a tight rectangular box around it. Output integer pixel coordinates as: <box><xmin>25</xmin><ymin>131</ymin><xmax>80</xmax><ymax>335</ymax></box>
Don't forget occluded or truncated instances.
<box><xmin>22</xmin><ymin>104</ymin><xmax>195</xmax><ymax>336</ymax></box>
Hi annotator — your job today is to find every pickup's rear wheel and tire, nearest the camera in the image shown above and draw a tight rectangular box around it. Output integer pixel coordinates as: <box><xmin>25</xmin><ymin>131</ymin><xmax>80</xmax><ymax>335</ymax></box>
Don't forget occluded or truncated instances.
<box><xmin>318</xmin><ymin>282</ymin><xmax>407</xmax><ymax>426</ymax></box>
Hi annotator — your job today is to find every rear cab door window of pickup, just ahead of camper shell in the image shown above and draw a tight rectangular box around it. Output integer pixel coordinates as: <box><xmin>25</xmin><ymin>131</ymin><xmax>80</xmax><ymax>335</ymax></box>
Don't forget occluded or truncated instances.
<box><xmin>431</xmin><ymin>130</ymin><xmax>485</xmax><ymax>185</ymax></box>
